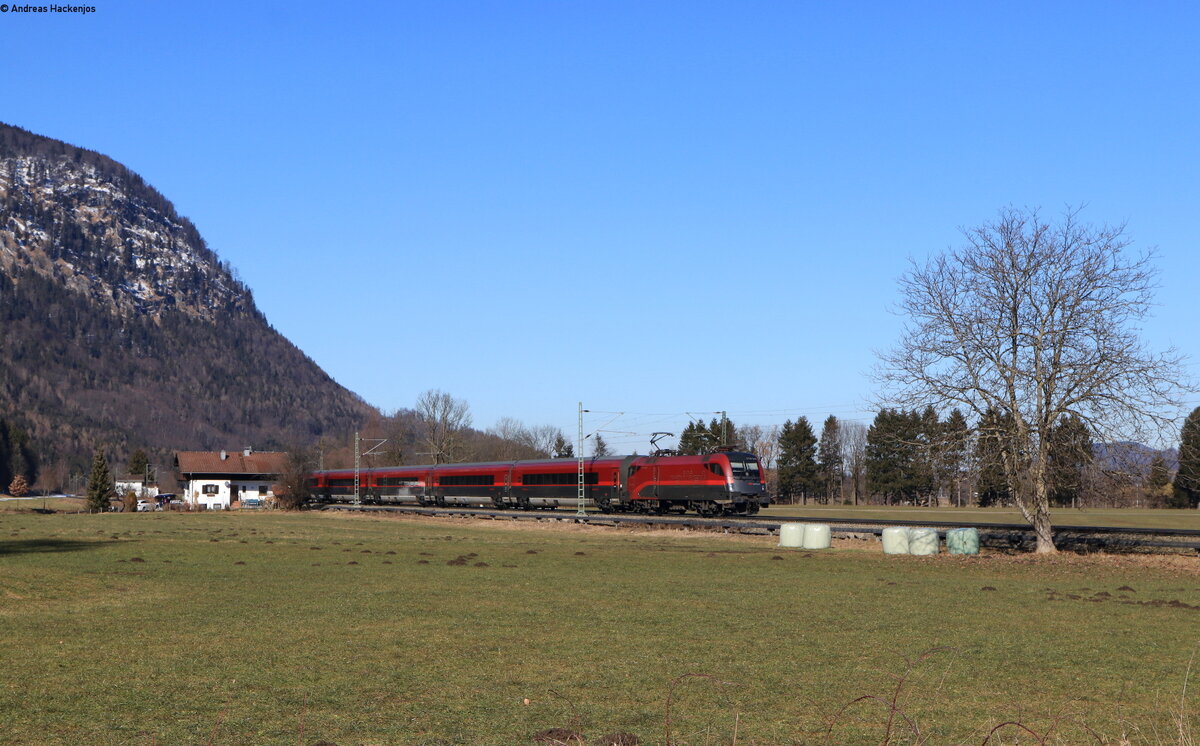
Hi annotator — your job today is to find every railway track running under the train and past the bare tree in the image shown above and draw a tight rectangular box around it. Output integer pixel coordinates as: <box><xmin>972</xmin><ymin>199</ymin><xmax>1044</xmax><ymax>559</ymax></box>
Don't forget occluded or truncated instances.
<box><xmin>323</xmin><ymin>505</ymin><xmax>1200</xmax><ymax>553</ymax></box>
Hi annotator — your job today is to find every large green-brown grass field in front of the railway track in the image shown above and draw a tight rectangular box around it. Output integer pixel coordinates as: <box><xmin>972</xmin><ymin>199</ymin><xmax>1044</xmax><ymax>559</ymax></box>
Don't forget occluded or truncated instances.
<box><xmin>0</xmin><ymin>513</ymin><xmax>1200</xmax><ymax>746</ymax></box>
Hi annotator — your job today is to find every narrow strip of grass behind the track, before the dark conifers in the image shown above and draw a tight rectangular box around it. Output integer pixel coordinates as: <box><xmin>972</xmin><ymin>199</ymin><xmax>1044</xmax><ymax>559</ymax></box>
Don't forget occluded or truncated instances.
<box><xmin>760</xmin><ymin>505</ymin><xmax>1200</xmax><ymax>529</ymax></box>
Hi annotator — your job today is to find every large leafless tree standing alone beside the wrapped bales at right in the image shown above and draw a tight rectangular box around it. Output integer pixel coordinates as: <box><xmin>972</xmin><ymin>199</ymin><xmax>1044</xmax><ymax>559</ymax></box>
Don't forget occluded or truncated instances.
<box><xmin>878</xmin><ymin>207</ymin><xmax>1189</xmax><ymax>552</ymax></box>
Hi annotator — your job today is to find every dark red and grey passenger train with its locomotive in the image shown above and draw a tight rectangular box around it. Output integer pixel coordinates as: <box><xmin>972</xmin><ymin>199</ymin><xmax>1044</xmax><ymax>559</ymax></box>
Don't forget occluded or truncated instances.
<box><xmin>310</xmin><ymin>451</ymin><xmax>770</xmax><ymax>516</ymax></box>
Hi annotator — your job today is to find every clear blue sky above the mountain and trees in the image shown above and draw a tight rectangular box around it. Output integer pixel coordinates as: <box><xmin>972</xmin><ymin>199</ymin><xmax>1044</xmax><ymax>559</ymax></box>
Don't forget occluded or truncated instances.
<box><xmin>0</xmin><ymin>0</ymin><xmax>1200</xmax><ymax>452</ymax></box>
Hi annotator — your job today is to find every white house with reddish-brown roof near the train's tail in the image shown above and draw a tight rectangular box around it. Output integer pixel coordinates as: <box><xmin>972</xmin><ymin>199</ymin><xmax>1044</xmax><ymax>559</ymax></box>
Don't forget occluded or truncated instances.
<box><xmin>175</xmin><ymin>449</ymin><xmax>288</xmax><ymax>510</ymax></box>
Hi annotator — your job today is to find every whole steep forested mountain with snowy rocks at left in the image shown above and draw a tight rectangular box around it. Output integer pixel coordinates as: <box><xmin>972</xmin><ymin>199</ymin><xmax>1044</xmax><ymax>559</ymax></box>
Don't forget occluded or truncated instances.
<box><xmin>0</xmin><ymin>124</ymin><xmax>374</xmax><ymax>488</ymax></box>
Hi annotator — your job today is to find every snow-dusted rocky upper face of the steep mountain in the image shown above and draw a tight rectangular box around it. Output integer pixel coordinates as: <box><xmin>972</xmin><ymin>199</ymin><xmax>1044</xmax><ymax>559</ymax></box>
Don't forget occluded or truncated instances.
<box><xmin>0</xmin><ymin>126</ymin><xmax>253</xmax><ymax>321</ymax></box>
